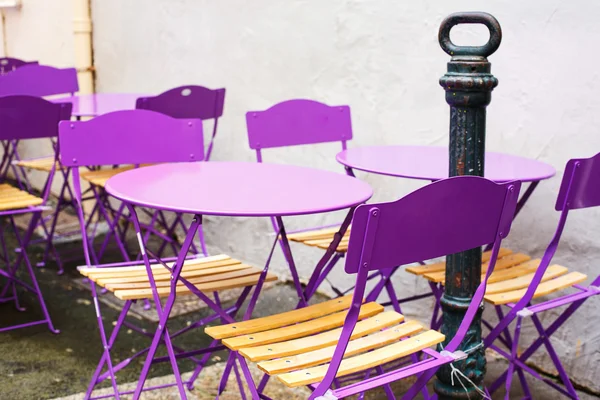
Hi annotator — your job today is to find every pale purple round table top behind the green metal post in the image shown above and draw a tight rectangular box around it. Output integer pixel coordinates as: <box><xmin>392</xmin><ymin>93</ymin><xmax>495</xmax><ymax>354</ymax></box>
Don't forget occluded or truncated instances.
<box><xmin>336</xmin><ymin>146</ymin><xmax>556</xmax><ymax>182</ymax></box>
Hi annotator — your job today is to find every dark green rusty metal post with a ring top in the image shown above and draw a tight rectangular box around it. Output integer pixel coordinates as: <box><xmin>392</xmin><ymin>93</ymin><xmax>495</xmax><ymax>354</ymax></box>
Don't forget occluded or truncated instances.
<box><xmin>434</xmin><ymin>12</ymin><xmax>502</xmax><ymax>400</ymax></box>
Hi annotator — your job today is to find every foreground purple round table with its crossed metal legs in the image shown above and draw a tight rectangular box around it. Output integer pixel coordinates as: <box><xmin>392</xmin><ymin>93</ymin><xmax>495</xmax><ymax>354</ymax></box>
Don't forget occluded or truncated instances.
<box><xmin>105</xmin><ymin>161</ymin><xmax>373</xmax><ymax>398</ymax></box>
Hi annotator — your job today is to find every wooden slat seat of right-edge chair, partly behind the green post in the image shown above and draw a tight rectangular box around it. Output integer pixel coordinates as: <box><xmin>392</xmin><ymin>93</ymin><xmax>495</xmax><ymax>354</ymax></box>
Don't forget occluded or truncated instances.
<box><xmin>406</xmin><ymin>249</ymin><xmax>587</xmax><ymax>305</ymax></box>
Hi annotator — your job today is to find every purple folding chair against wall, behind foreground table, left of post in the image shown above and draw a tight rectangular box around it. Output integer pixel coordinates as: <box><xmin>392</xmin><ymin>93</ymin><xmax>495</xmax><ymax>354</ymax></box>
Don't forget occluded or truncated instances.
<box><xmin>246</xmin><ymin>99</ymin><xmax>352</xmax><ymax>300</ymax></box>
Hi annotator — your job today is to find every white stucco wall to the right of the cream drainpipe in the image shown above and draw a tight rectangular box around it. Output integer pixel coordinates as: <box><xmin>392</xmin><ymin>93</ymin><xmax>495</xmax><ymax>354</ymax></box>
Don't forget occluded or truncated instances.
<box><xmin>89</xmin><ymin>0</ymin><xmax>600</xmax><ymax>391</ymax></box>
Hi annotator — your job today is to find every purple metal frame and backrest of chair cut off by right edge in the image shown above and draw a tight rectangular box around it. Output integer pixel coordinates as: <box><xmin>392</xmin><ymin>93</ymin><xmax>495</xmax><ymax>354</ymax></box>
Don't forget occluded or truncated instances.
<box><xmin>484</xmin><ymin>153</ymin><xmax>600</xmax><ymax>399</ymax></box>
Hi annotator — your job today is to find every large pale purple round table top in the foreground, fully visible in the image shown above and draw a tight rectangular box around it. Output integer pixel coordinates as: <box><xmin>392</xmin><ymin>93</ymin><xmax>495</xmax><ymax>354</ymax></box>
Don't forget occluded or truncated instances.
<box><xmin>106</xmin><ymin>161</ymin><xmax>373</xmax><ymax>217</ymax></box>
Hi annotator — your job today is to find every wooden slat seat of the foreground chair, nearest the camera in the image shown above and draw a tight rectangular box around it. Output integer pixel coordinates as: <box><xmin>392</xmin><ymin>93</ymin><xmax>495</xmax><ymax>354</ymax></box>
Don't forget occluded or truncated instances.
<box><xmin>205</xmin><ymin>295</ymin><xmax>444</xmax><ymax>387</ymax></box>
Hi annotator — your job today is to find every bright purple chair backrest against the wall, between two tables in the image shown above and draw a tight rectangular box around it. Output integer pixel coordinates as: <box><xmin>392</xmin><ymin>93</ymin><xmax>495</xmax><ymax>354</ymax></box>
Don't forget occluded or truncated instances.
<box><xmin>246</xmin><ymin>99</ymin><xmax>352</xmax><ymax>160</ymax></box>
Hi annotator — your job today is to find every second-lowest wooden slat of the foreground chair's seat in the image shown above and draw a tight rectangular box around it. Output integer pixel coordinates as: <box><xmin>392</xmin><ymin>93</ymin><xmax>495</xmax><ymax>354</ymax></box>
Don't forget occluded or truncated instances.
<box><xmin>258</xmin><ymin>321</ymin><xmax>423</xmax><ymax>375</ymax></box>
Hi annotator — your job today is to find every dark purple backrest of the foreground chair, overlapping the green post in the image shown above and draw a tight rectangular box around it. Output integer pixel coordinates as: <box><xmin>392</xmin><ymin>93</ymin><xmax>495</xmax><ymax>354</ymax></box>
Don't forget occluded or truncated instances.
<box><xmin>346</xmin><ymin>176</ymin><xmax>520</xmax><ymax>273</ymax></box>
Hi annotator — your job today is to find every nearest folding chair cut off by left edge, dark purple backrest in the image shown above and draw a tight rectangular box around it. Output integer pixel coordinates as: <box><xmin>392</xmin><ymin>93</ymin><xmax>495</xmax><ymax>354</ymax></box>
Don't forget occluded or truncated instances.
<box><xmin>0</xmin><ymin>96</ymin><xmax>72</xmax><ymax>333</ymax></box>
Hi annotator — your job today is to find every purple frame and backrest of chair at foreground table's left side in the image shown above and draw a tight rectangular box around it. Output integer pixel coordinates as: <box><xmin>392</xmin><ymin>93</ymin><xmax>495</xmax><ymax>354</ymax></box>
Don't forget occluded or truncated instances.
<box><xmin>59</xmin><ymin>110</ymin><xmax>248</xmax><ymax>399</ymax></box>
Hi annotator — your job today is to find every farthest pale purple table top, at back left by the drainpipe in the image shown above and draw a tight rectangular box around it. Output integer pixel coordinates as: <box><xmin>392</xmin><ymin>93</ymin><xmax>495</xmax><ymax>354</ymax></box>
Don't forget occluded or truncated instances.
<box><xmin>51</xmin><ymin>93</ymin><xmax>145</xmax><ymax>117</ymax></box>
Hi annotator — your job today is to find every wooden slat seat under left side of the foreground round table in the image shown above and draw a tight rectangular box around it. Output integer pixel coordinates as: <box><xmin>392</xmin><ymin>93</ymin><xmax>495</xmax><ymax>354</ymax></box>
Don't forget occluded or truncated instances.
<box><xmin>79</xmin><ymin>255</ymin><xmax>277</xmax><ymax>300</ymax></box>
